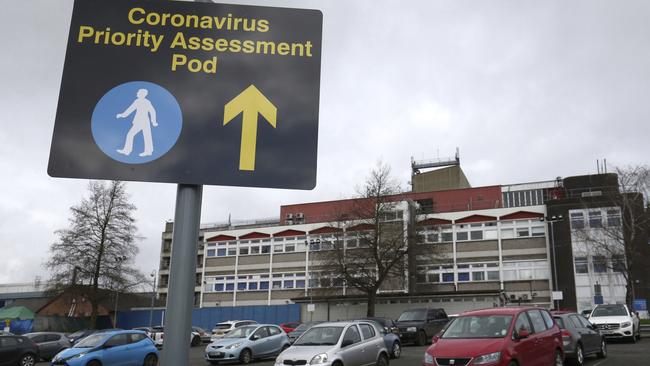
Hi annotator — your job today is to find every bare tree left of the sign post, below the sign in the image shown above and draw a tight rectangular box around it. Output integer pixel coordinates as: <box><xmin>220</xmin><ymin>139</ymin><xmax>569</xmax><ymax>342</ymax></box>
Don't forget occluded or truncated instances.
<box><xmin>46</xmin><ymin>181</ymin><xmax>145</xmax><ymax>328</ymax></box>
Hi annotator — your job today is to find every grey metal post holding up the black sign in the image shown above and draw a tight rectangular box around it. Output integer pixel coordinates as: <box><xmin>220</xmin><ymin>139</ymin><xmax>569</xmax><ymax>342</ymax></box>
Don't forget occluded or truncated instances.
<box><xmin>162</xmin><ymin>184</ymin><xmax>203</xmax><ymax>366</ymax></box>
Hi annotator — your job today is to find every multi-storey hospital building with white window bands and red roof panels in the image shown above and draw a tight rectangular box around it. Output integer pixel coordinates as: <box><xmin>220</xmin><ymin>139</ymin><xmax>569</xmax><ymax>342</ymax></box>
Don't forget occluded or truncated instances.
<box><xmin>159</xmin><ymin>167</ymin><xmax>648</xmax><ymax>319</ymax></box>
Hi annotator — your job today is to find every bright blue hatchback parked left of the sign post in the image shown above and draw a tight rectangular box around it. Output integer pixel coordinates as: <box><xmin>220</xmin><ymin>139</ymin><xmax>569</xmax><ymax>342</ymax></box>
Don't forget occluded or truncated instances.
<box><xmin>52</xmin><ymin>330</ymin><xmax>158</xmax><ymax>366</ymax></box>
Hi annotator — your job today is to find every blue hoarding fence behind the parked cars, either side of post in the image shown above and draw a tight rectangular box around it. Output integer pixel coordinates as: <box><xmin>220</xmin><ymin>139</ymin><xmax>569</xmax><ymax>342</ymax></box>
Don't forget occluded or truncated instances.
<box><xmin>117</xmin><ymin>304</ymin><xmax>300</xmax><ymax>331</ymax></box>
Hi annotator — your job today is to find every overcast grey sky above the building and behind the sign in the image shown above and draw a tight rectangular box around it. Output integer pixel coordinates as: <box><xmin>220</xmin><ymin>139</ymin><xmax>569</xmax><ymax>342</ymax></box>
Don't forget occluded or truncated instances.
<box><xmin>0</xmin><ymin>0</ymin><xmax>650</xmax><ymax>283</ymax></box>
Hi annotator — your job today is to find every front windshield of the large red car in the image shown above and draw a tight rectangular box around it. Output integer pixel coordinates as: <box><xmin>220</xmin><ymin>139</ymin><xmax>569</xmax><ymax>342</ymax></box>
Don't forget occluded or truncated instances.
<box><xmin>442</xmin><ymin>315</ymin><xmax>512</xmax><ymax>338</ymax></box>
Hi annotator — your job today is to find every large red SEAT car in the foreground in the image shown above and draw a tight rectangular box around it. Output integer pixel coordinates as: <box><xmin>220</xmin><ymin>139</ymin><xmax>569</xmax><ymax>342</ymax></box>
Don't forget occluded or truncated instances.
<box><xmin>422</xmin><ymin>307</ymin><xmax>564</xmax><ymax>366</ymax></box>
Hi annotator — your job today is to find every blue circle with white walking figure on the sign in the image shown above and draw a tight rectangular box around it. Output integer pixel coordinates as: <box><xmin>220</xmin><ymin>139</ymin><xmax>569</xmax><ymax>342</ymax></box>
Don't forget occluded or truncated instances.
<box><xmin>91</xmin><ymin>81</ymin><xmax>183</xmax><ymax>164</ymax></box>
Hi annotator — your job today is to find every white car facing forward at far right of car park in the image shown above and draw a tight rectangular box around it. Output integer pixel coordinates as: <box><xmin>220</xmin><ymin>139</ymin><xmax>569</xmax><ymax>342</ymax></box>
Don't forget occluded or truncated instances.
<box><xmin>589</xmin><ymin>304</ymin><xmax>641</xmax><ymax>343</ymax></box>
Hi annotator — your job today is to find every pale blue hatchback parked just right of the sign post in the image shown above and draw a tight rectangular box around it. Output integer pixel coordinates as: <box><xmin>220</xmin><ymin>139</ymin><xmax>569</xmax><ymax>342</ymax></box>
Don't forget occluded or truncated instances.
<box><xmin>204</xmin><ymin>324</ymin><xmax>289</xmax><ymax>365</ymax></box>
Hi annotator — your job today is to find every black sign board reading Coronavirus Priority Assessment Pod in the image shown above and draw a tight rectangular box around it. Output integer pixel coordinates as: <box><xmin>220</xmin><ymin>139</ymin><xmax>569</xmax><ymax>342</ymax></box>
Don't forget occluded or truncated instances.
<box><xmin>48</xmin><ymin>0</ymin><xmax>322</xmax><ymax>189</ymax></box>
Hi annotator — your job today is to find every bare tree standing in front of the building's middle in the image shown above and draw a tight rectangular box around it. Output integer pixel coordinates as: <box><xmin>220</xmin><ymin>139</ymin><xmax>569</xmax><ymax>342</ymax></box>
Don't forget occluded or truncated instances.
<box><xmin>321</xmin><ymin>163</ymin><xmax>414</xmax><ymax>316</ymax></box>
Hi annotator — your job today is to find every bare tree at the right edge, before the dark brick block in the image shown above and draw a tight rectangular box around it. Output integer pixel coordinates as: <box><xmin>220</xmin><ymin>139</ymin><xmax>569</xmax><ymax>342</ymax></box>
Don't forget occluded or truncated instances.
<box><xmin>575</xmin><ymin>166</ymin><xmax>650</xmax><ymax>304</ymax></box>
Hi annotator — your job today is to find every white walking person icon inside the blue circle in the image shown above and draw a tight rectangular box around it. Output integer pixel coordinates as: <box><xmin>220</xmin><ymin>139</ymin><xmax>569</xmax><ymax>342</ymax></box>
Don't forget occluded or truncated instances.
<box><xmin>116</xmin><ymin>89</ymin><xmax>158</xmax><ymax>156</ymax></box>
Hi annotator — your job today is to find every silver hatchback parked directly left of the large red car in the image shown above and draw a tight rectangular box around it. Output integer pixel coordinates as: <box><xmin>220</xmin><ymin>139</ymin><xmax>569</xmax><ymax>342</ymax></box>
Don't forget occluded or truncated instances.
<box><xmin>275</xmin><ymin>321</ymin><xmax>389</xmax><ymax>366</ymax></box>
